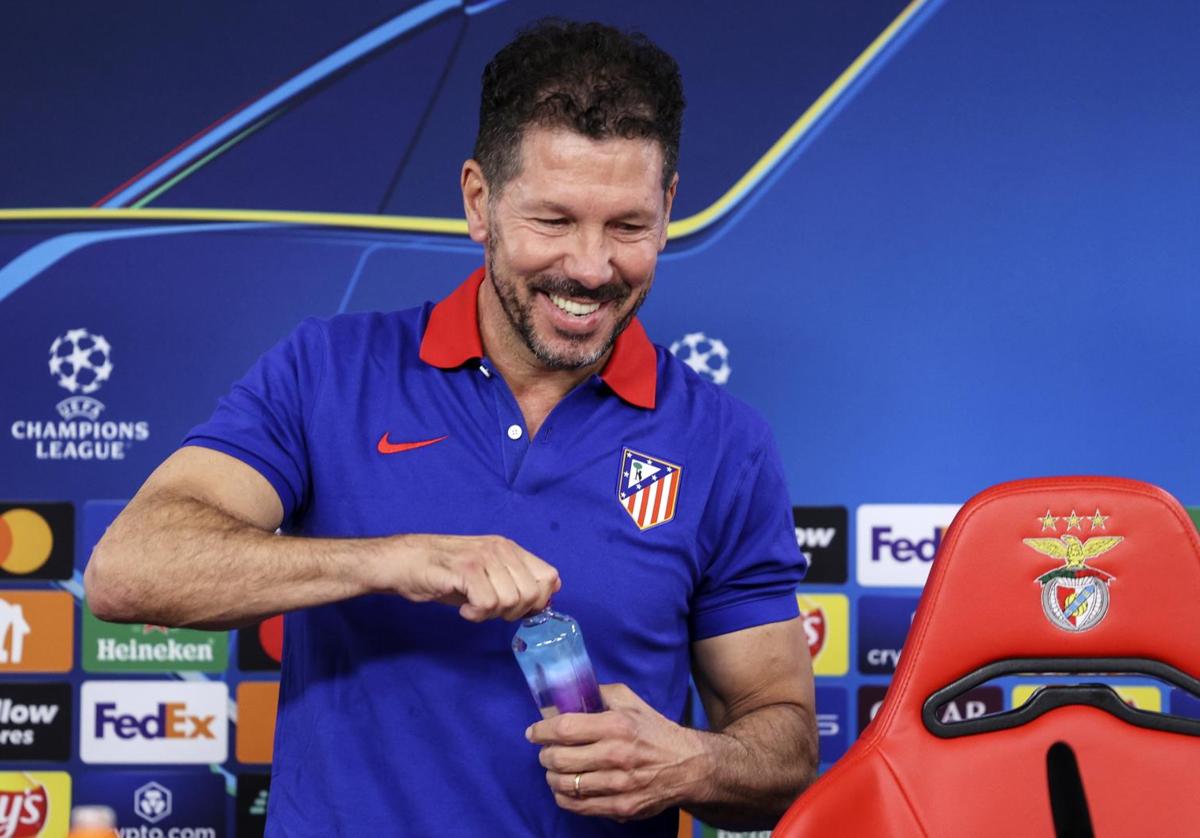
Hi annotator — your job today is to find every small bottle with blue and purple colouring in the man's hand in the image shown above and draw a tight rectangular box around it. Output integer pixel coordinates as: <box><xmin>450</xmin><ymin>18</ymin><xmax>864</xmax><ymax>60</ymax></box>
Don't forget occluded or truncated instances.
<box><xmin>512</xmin><ymin>607</ymin><xmax>605</xmax><ymax>719</ymax></box>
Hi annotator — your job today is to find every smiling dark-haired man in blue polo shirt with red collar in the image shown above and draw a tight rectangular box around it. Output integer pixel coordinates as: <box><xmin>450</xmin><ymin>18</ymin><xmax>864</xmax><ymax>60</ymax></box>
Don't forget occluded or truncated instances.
<box><xmin>85</xmin><ymin>16</ymin><xmax>816</xmax><ymax>836</ymax></box>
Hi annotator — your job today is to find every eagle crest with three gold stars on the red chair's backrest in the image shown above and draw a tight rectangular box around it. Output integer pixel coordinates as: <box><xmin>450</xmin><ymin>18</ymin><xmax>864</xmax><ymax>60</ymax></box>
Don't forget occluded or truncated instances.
<box><xmin>1022</xmin><ymin>510</ymin><xmax>1124</xmax><ymax>632</ymax></box>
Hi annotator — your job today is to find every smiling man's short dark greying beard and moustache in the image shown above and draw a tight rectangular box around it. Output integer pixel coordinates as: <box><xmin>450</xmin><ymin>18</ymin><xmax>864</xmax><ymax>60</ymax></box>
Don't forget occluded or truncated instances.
<box><xmin>487</xmin><ymin>228</ymin><xmax>653</xmax><ymax>370</ymax></box>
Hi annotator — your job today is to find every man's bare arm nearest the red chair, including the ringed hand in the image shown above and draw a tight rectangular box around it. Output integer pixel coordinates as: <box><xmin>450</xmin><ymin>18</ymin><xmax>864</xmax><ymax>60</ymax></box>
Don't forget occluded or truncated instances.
<box><xmin>527</xmin><ymin>619</ymin><xmax>817</xmax><ymax>830</ymax></box>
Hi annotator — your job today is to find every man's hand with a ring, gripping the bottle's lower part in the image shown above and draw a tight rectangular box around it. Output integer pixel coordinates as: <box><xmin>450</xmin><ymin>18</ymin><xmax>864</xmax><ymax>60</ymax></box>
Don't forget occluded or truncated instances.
<box><xmin>526</xmin><ymin>684</ymin><xmax>706</xmax><ymax>820</ymax></box>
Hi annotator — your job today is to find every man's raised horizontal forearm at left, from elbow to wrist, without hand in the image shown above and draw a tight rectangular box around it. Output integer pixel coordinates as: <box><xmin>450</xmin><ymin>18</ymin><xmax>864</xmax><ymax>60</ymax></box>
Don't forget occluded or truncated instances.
<box><xmin>84</xmin><ymin>493</ymin><xmax>382</xmax><ymax>629</ymax></box>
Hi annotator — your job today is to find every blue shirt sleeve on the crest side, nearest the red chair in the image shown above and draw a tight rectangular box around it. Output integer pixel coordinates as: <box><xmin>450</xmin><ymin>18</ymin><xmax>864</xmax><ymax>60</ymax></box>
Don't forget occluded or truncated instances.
<box><xmin>691</xmin><ymin>432</ymin><xmax>808</xmax><ymax>640</ymax></box>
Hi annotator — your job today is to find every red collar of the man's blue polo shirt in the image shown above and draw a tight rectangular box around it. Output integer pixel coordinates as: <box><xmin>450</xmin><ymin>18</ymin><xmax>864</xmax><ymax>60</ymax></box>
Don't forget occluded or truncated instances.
<box><xmin>421</xmin><ymin>268</ymin><xmax>658</xmax><ymax>408</ymax></box>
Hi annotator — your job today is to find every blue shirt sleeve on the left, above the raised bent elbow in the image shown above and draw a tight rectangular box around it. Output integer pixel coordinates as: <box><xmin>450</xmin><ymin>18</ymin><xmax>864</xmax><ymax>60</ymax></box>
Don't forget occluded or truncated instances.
<box><xmin>182</xmin><ymin>318</ymin><xmax>326</xmax><ymax>521</ymax></box>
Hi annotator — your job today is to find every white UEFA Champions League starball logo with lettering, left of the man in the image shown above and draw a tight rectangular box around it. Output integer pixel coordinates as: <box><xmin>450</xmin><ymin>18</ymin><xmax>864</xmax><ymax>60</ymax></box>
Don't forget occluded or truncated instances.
<box><xmin>10</xmin><ymin>328</ymin><xmax>150</xmax><ymax>460</ymax></box>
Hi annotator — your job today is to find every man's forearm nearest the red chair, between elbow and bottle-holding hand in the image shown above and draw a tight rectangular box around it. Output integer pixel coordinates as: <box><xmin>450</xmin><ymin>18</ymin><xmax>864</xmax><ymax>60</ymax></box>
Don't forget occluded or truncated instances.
<box><xmin>680</xmin><ymin>704</ymin><xmax>817</xmax><ymax>830</ymax></box>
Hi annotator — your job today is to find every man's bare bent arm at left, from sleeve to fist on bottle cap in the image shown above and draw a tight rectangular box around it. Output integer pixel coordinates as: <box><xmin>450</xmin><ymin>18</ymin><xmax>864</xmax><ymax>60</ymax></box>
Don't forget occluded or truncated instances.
<box><xmin>84</xmin><ymin>447</ymin><xmax>559</xmax><ymax>629</ymax></box>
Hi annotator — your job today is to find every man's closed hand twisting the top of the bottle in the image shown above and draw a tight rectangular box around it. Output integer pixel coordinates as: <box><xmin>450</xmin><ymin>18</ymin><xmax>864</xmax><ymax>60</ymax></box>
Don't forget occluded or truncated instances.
<box><xmin>367</xmin><ymin>535</ymin><xmax>562</xmax><ymax>623</ymax></box>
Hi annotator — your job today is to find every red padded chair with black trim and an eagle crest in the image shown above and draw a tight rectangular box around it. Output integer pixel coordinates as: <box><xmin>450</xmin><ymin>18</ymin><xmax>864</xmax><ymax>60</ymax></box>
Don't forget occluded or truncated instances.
<box><xmin>773</xmin><ymin>478</ymin><xmax>1200</xmax><ymax>838</ymax></box>
